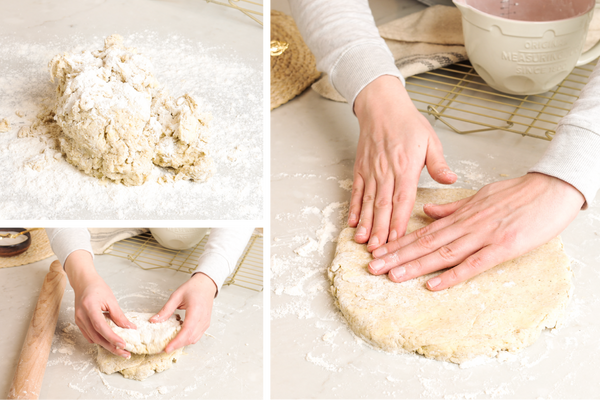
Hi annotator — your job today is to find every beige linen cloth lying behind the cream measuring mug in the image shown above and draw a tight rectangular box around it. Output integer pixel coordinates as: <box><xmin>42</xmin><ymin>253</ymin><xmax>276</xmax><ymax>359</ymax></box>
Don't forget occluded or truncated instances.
<box><xmin>311</xmin><ymin>6</ymin><xmax>600</xmax><ymax>102</ymax></box>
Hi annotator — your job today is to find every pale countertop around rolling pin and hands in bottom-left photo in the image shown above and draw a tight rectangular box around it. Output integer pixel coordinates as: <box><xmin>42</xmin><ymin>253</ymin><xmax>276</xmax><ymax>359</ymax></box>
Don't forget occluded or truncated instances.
<box><xmin>0</xmin><ymin>255</ymin><xmax>266</xmax><ymax>400</ymax></box>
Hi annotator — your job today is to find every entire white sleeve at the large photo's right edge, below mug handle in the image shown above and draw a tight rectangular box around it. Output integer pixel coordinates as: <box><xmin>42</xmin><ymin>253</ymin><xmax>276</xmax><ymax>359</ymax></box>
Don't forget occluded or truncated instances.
<box><xmin>529</xmin><ymin>63</ymin><xmax>600</xmax><ymax>209</ymax></box>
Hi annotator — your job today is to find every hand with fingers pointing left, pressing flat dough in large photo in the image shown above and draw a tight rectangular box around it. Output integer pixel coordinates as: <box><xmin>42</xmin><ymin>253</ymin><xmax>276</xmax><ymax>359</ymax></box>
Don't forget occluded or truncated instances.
<box><xmin>368</xmin><ymin>173</ymin><xmax>585</xmax><ymax>290</ymax></box>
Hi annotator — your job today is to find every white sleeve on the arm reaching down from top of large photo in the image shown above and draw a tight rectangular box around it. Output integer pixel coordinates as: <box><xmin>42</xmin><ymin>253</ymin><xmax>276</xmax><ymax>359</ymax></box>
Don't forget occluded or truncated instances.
<box><xmin>290</xmin><ymin>0</ymin><xmax>405</xmax><ymax>109</ymax></box>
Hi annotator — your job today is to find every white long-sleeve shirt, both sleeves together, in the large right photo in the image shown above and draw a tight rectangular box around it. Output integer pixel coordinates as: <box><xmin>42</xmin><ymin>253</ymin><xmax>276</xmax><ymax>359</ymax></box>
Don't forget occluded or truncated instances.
<box><xmin>290</xmin><ymin>0</ymin><xmax>600</xmax><ymax>208</ymax></box>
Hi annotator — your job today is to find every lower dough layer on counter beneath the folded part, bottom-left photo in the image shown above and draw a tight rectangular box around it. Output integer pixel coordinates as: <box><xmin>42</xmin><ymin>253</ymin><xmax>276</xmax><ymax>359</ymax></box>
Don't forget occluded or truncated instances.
<box><xmin>97</xmin><ymin>346</ymin><xmax>183</xmax><ymax>381</ymax></box>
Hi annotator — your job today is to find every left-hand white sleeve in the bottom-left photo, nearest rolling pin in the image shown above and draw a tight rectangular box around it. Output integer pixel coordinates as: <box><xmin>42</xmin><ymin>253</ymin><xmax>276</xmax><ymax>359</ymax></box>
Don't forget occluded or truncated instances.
<box><xmin>45</xmin><ymin>225</ymin><xmax>94</xmax><ymax>268</ymax></box>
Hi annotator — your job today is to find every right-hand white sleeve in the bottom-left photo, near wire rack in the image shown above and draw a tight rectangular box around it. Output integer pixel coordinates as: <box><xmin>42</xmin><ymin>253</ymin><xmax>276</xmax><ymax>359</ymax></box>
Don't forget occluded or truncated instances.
<box><xmin>193</xmin><ymin>225</ymin><xmax>254</xmax><ymax>293</ymax></box>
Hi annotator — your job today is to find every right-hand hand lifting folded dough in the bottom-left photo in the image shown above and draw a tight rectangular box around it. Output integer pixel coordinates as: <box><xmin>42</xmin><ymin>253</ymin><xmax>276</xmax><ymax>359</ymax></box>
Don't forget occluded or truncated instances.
<box><xmin>150</xmin><ymin>272</ymin><xmax>217</xmax><ymax>353</ymax></box>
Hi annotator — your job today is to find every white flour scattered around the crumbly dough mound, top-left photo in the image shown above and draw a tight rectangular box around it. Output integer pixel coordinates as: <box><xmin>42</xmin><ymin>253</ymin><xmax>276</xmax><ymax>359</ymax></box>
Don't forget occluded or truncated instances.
<box><xmin>0</xmin><ymin>31</ymin><xmax>266</xmax><ymax>222</ymax></box>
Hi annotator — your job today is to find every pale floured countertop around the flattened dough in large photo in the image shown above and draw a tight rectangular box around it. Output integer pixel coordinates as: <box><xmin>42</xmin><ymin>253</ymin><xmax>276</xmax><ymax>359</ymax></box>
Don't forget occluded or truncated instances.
<box><xmin>267</xmin><ymin>0</ymin><xmax>600</xmax><ymax>400</ymax></box>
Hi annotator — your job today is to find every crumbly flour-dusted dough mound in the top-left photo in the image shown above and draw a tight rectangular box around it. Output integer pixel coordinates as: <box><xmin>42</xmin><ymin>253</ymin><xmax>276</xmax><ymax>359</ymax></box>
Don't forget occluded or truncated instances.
<box><xmin>49</xmin><ymin>35</ymin><xmax>214</xmax><ymax>186</ymax></box>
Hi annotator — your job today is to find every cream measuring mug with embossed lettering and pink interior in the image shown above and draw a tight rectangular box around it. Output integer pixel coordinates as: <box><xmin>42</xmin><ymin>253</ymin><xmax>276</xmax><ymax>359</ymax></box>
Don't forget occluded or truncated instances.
<box><xmin>452</xmin><ymin>0</ymin><xmax>600</xmax><ymax>95</ymax></box>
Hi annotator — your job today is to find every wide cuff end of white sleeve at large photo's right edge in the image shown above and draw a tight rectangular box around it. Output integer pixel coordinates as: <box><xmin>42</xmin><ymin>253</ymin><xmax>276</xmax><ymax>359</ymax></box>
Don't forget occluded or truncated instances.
<box><xmin>529</xmin><ymin>124</ymin><xmax>600</xmax><ymax>209</ymax></box>
